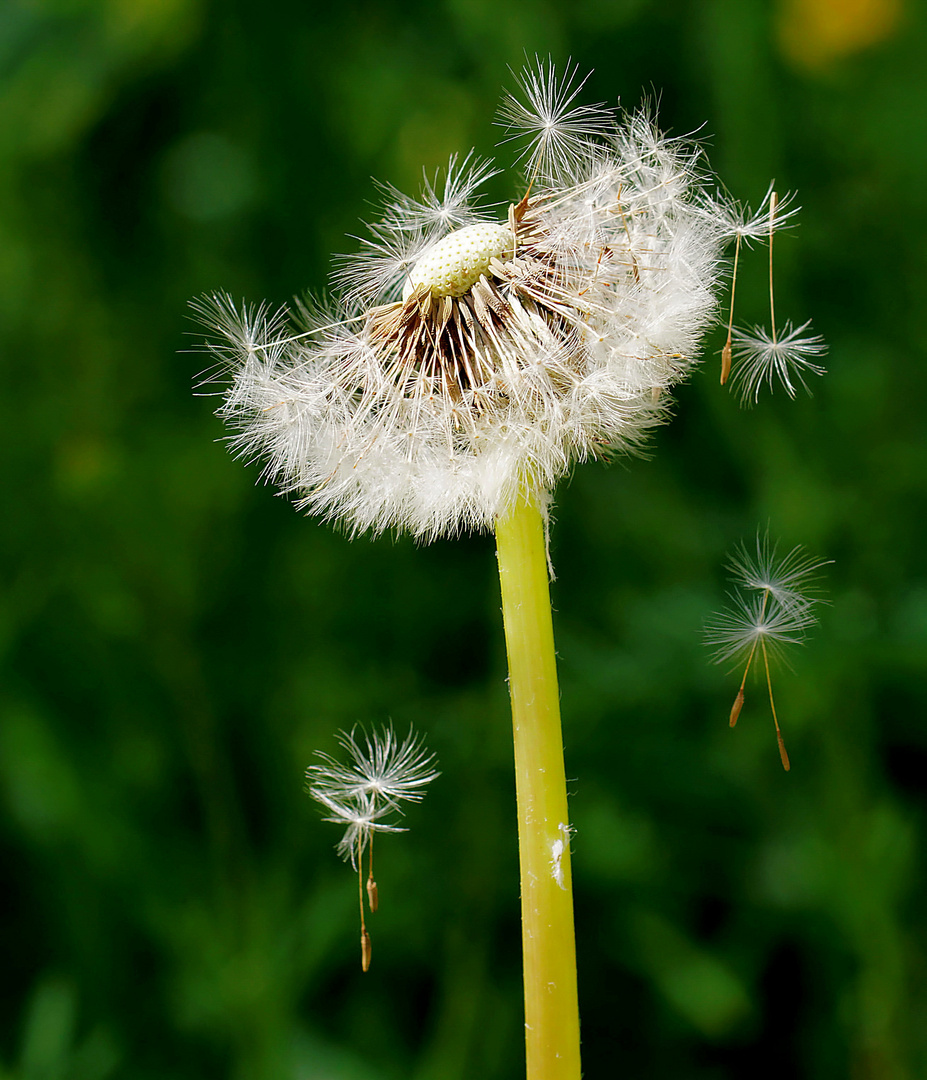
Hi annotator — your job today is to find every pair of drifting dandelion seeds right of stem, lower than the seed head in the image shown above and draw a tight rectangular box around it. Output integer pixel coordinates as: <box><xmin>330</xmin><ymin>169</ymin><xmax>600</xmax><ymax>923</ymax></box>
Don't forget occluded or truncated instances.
<box><xmin>706</xmin><ymin>532</ymin><xmax>829</xmax><ymax>772</ymax></box>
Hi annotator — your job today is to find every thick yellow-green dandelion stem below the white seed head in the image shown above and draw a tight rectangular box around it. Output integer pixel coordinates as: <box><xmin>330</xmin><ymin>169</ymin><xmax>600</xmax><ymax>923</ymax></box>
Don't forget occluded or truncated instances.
<box><xmin>496</xmin><ymin>500</ymin><xmax>580</xmax><ymax>1080</ymax></box>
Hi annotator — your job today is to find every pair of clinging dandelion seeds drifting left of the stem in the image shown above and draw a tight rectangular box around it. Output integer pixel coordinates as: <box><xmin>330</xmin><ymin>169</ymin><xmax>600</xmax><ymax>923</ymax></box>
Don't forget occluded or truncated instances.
<box><xmin>306</xmin><ymin>726</ymin><xmax>440</xmax><ymax>971</ymax></box>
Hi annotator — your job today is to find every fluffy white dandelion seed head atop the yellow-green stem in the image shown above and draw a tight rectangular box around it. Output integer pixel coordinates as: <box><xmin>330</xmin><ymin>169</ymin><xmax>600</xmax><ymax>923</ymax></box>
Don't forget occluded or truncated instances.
<box><xmin>198</xmin><ymin>63</ymin><xmax>795</xmax><ymax>539</ymax></box>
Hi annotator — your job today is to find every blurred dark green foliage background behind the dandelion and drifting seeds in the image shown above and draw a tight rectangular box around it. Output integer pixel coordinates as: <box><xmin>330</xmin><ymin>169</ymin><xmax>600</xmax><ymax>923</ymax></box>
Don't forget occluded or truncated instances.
<box><xmin>0</xmin><ymin>0</ymin><xmax>927</xmax><ymax>1080</ymax></box>
